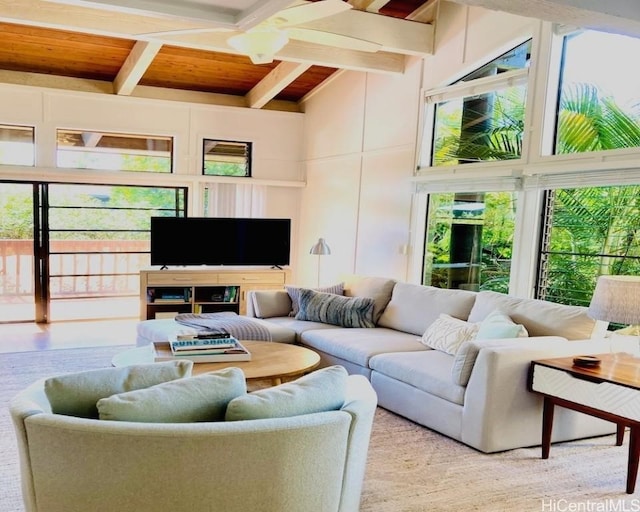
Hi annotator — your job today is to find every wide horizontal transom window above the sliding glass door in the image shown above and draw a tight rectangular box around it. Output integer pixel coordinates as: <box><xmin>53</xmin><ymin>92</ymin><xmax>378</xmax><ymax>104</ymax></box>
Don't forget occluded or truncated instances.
<box><xmin>56</xmin><ymin>130</ymin><xmax>173</xmax><ymax>173</ymax></box>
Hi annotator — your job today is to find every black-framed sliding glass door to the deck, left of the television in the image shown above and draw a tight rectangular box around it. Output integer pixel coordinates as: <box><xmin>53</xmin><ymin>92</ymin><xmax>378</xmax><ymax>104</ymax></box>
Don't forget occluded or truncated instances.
<box><xmin>0</xmin><ymin>183</ymin><xmax>186</xmax><ymax>322</ymax></box>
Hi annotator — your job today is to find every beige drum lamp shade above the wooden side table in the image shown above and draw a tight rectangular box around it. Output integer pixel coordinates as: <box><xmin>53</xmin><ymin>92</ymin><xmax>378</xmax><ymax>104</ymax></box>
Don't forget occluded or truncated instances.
<box><xmin>587</xmin><ymin>276</ymin><xmax>640</xmax><ymax>325</ymax></box>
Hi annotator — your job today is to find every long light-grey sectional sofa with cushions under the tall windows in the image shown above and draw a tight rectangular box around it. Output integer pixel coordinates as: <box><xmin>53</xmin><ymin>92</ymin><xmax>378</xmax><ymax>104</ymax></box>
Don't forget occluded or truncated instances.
<box><xmin>247</xmin><ymin>276</ymin><xmax>615</xmax><ymax>453</ymax></box>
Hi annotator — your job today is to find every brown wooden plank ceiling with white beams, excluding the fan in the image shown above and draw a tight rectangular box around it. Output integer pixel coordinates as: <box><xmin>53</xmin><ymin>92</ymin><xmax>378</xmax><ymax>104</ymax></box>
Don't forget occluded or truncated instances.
<box><xmin>0</xmin><ymin>0</ymin><xmax>438</xmax><ymax>110</ymax></box>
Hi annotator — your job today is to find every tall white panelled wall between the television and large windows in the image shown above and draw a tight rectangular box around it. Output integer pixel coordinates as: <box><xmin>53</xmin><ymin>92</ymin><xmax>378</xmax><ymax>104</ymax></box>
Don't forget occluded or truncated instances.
<box><xmin>298</xmin><ymin>59</ymin><xmax>422</xmax><ymax>285</ymax></box>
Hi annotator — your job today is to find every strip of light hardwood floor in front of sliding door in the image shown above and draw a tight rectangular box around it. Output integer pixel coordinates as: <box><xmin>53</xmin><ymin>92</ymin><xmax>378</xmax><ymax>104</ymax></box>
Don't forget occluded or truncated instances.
<box><xmin>0</xmin><ymin>318</ymin><xmax>139</xmax><ymax>353</ymax></box>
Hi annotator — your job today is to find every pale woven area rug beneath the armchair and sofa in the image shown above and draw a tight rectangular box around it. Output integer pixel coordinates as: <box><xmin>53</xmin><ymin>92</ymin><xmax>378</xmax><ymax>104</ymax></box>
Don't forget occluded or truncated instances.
<box><xmin>0</xmin><ymin>347</ymin><xmax>640</xmax><ymax>512</ymax></box>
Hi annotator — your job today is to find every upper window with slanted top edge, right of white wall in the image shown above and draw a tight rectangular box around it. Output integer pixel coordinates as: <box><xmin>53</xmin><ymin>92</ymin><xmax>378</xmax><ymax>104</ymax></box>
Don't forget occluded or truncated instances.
<box><xmin>424</xmin><ymin>41</ymin><xmax>531</xmax><ymax>166</ymax></box>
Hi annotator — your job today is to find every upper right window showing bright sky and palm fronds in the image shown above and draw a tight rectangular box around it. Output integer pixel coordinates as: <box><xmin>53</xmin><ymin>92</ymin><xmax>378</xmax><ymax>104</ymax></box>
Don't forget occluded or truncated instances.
<box><xmin>555</xmin><ymin>31</ymin><xmax>640</xmax><ymax>154</ymax></box>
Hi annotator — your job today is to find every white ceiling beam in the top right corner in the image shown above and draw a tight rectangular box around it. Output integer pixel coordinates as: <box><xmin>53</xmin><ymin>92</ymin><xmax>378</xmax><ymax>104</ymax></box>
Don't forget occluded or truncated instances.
<box><xmin>453</xmin><ymin>0</ymin><xmax>640</xmax><ymax>37</ymax></box>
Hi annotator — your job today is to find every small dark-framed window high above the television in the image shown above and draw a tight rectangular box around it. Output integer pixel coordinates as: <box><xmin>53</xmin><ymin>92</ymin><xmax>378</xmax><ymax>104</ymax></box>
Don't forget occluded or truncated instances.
<box><xmin>202</xmin><ymin>139</ymin><xmax>251</xmax><ymax>177</ymax></box>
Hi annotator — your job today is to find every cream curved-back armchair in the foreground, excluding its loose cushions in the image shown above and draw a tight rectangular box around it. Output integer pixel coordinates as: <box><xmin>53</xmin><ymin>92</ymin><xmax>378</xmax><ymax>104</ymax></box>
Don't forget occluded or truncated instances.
<box><xmin>11</xmin><ymin>376</ymin><xmax>376</xmax><ymax>512</ymax></box>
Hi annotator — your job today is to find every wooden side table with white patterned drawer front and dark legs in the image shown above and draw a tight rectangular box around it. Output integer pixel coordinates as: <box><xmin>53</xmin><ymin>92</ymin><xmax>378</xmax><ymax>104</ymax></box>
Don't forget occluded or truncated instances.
<box><xmin>529</xmin><ymin>353</ymin><xmax>640</xmax><ymax>494</ymax></box>
